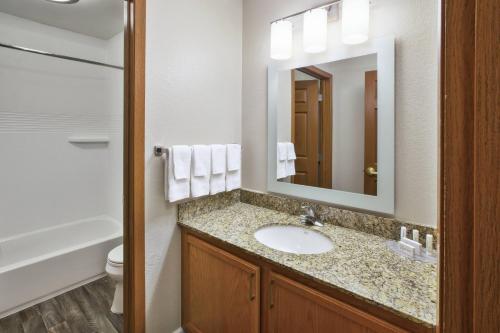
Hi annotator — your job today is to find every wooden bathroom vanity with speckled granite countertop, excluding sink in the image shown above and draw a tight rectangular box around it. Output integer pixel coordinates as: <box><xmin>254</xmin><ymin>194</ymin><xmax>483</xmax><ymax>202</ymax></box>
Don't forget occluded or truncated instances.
<box><xmin>179</xmin><ymin>202</ymin><xmax>437</xmax><ymax>332</ymax></box>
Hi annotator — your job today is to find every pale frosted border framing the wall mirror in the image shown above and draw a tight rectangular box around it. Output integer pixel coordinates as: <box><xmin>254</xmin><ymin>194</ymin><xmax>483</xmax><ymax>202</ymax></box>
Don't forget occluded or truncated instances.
<box><xmin>267</xmin><ymin>37</ymin><xmax>395</xmax><ymax>215</ymax></box>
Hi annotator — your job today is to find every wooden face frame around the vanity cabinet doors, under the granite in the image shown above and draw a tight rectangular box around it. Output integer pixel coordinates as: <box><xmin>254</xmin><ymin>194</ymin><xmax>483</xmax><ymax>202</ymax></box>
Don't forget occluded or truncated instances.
<box><xmin>181</xmin><ymin>226</ymin><xmax>435</xmax><ymax>333</ymax></box>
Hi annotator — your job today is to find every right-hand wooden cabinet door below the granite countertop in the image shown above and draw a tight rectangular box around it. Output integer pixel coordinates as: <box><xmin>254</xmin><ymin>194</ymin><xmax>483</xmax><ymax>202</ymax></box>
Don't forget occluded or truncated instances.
<box><xmin>267</xmin><ymin>273</ymin><xmax>406</xmax><ymax>333</ymax></box>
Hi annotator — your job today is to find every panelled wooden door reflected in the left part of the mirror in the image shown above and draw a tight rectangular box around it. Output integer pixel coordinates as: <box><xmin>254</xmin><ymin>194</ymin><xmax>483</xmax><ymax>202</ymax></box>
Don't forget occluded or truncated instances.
<box><xmin>292</xmin><ymin>80</ymin><xmax>319</xmax><ymax>186</ymax></box>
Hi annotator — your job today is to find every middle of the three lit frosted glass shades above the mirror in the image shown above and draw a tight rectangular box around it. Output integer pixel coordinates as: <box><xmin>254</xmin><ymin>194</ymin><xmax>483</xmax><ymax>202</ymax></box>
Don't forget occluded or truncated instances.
<box><xmin>303</xmin><ymin>8</ymin><xmax>328</xmax><ymax>53</ymax></box>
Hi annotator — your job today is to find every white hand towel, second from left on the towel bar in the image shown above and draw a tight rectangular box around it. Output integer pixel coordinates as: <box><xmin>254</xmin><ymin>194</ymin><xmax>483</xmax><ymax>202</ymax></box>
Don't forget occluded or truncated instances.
<box><xmin>191</xmin><ymin>145</ymin><xmax>211</xmax><ymax>198</ymax></box>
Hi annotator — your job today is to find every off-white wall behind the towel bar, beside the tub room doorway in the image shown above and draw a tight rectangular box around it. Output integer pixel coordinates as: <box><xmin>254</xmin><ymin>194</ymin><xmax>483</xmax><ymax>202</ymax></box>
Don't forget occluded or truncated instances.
<box><xmin>145</xmin><ymin>0</ymin><xmax>242</xmax><ymax>333</ymax></box>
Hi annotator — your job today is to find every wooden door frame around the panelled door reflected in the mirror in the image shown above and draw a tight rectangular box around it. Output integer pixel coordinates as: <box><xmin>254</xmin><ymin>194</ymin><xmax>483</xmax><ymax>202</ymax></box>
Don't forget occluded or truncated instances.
<box><xmin>292</xmin><ymin>66</ymin><xmax>333</xmax><ymax>189</ymax></box>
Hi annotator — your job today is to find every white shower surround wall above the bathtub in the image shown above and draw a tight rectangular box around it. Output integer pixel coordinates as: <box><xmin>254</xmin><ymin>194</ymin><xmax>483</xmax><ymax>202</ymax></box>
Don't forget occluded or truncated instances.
<box><xmin>0</xmin><ymin>13</ymin><xmax>123</xmax><ymax>238</ymax></box>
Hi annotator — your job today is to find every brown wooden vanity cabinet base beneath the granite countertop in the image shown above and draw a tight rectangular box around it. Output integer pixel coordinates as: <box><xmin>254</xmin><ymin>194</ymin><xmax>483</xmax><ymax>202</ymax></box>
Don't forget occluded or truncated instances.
<box><xmin>182</xmin><ymin>229</ymin><xmax>426</xmax><ymax>333</ymax></box>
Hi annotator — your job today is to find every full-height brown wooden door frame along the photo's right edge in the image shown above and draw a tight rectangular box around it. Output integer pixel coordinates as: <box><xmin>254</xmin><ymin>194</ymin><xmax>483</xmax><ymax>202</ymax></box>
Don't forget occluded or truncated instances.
<box><xmin>438</xmin><ymin>0</ymin><xmax>500</xmax><ymax>333</ymax></box>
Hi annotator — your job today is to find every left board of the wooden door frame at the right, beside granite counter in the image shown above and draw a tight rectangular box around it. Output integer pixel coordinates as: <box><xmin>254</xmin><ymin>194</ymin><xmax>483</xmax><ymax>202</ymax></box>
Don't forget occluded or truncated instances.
<box><xmin>439</xmin><ymin>0</ymin><xmax>475</xmax><ymax>326</ymax></box>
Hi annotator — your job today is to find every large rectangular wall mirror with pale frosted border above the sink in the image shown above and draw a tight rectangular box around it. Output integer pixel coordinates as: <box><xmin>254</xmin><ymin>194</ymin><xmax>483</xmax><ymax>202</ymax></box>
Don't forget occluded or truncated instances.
<box><xmin>268</xmin><ymin>38</ymin><xmax>394</xmax><ymax>214</ymax></box>
